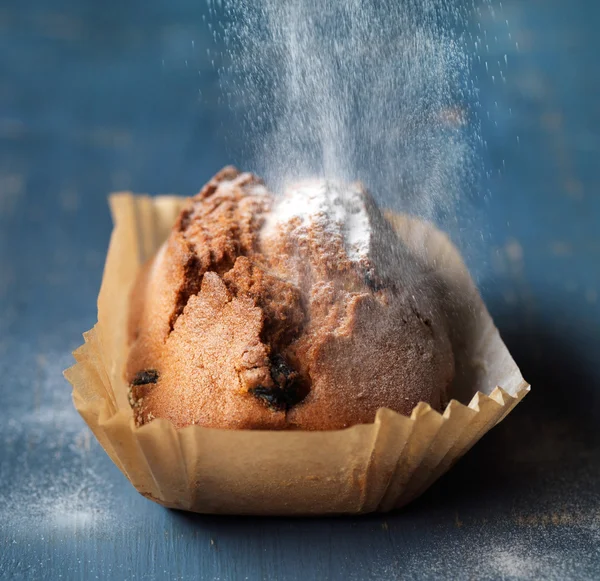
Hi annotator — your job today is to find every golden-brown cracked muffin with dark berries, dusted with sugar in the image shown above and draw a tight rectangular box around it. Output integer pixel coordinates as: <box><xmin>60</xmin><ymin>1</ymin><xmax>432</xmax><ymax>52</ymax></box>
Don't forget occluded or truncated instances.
<box><xmin>125</xmin><ymin>167</ymin><xmax>454</xmax><ymax>430</ymax></box>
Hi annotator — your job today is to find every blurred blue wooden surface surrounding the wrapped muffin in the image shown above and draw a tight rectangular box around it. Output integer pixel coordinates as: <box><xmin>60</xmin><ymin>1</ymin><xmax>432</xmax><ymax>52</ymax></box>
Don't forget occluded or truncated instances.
<box><xmin>0</xmin><ymin>0</ymin><xmax>600</xmax><ymax>580</ymax></box>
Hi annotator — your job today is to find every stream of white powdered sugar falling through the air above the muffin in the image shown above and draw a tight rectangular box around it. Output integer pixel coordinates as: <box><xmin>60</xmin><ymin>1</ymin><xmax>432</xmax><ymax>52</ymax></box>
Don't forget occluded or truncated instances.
<box><xmin>211</xmin><ymin>0</ymin><xmax>496</xmax><ymax>230</ymax></box>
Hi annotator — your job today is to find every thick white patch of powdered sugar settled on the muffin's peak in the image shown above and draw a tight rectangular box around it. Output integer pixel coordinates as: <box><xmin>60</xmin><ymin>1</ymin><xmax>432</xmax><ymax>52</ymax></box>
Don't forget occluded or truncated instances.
<box><xmin>264</xmin><ymin>178</ymin><xmax>371</xmax><ymax>261</ymax></box>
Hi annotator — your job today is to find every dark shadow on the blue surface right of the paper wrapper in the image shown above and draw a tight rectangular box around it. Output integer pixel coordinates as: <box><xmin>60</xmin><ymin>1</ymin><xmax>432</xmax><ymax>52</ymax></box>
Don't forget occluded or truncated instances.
<box><xmin>407</xmin><ymin>295</ymin><xmax>600</xmax><ymax>511</ymax></box>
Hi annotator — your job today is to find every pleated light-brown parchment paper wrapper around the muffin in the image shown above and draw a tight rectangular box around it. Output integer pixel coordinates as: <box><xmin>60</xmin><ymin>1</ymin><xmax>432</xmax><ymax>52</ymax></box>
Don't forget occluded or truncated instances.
<box><xmin>65</xmin><ymin>194</ymin><xmax>529</xmax><ymax>515</ymax></box>
